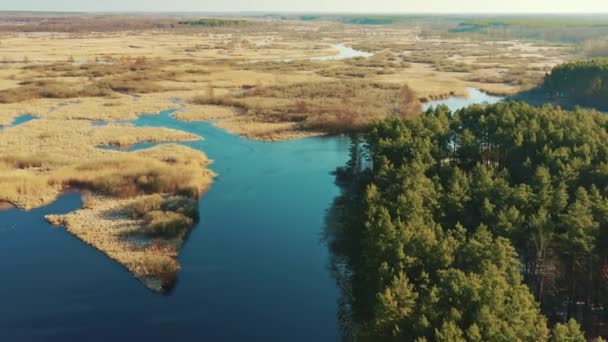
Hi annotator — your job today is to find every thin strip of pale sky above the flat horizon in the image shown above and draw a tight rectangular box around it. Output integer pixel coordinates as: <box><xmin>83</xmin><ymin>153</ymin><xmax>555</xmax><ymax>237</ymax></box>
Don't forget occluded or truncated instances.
<box><xmin>0</xmin><ymin>0</ymin><xmax>608</xmax><ymax>13</ymax></box>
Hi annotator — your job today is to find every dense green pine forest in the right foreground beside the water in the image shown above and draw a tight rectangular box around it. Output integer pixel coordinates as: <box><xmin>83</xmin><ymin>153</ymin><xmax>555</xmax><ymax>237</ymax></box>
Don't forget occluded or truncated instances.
<box><xmin>327</xmin><ymin>102</ymin><xmax>608</xmax><ymax>342</ymax></box>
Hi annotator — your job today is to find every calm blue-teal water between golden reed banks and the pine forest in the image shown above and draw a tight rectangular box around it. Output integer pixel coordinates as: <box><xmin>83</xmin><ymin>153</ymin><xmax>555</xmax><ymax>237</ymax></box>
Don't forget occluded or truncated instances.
<box><xmin>0</xmin><ymin>89</ymin><xmax>498</xmax><ymax>341</ymax></box>
